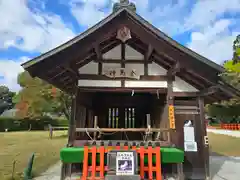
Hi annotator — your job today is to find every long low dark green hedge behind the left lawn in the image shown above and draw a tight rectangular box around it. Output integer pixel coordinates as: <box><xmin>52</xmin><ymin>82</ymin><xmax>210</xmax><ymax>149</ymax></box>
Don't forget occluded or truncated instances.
<box><xmin>0</xmin><ymin>117</ymin><xmax>68</xmax><ymax>132</ymax></box>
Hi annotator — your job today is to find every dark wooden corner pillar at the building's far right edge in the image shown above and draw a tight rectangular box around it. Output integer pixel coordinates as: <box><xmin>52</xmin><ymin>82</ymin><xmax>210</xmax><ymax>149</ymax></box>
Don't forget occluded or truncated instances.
<box><xmin>198</xmin><ymin>97</ymin><xmax>210</xmax><ymax>179</ymax></box>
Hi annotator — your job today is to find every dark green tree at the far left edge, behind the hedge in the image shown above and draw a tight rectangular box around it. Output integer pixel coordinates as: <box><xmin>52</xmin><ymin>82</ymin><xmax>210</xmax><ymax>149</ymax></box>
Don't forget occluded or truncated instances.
<box><xmin>0</xmin><ymin>86</ymin><xmax>15</xmax><ymax>115</ymax></box>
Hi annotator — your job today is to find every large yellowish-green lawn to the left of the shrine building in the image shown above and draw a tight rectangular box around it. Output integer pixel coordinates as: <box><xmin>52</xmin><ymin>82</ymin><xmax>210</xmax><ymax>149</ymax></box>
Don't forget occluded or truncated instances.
<box><xmin>0</xmin><ymin>131</ymin><xmax>67</xmax><ymax>180</ymax></box>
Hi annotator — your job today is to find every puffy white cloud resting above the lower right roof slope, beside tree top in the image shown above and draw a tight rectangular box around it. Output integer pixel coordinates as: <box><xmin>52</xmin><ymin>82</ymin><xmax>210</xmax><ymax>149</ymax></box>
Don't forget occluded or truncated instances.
<box><xmin>187</xmin><ymin>20</ymin><xmax>240</xmax><ymax>64</ymax></box>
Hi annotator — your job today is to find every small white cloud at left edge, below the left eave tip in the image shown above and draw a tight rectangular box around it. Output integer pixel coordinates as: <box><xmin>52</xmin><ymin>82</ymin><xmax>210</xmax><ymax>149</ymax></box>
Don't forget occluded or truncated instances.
<box><xmin>0</xmin><ymin>57</ymin><xmax>29</xmax><ymax>92</ymax></box>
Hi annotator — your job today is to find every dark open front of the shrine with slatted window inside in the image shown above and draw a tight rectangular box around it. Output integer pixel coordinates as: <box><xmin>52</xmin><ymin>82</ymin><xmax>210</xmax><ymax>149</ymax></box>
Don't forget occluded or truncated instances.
<box><xmin>93</xmin><ymin>92</ymin><xmax>165</xmax><ymax>140</ymax></box>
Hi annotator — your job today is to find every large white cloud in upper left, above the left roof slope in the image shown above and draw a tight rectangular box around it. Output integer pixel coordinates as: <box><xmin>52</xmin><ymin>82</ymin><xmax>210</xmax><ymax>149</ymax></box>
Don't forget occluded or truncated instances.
<box><xmin>0</xmin><ymin>0</ymin><xmax>75</xmax><ymax>53</ymax></box>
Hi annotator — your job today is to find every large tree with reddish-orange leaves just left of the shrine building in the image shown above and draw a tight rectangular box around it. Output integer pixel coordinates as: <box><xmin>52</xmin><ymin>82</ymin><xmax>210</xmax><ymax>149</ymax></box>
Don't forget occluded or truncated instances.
<box><xmin>15</xmin><ymin>71</ymin><xmax>71</xmax><ymax>119</ymax></box>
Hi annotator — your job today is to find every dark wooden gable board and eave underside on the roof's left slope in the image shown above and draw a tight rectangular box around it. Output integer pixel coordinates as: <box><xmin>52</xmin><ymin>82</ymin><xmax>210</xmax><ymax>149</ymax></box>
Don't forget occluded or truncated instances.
<box><xmin>29</xmin><ymin>14</ymin><xmax>123</xmax><ymax>76</ymax></box>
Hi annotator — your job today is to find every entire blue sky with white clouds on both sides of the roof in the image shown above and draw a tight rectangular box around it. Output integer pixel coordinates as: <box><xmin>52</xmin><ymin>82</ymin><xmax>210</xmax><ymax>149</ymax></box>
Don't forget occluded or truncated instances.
<box><xmin>0</xmin><ymin>0</ymin><xmax>240</xmax><ymax>91</ymax></box>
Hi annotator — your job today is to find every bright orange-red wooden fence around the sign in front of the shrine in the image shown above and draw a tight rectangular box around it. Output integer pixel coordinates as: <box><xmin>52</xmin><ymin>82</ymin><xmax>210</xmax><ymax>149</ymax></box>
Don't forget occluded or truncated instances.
<box><xmin>81</xmin><ymin>145</ymin><xmax>162</xmax><ymax>180</ymax></box>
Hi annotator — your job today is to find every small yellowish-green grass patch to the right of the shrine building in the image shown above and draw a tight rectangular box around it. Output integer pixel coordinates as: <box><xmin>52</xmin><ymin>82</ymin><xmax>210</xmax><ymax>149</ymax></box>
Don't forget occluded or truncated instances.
<box><xmin>208</xmin><ymin>133</ymin><xmax>240</xmax><ymax>157</ymax></box>
